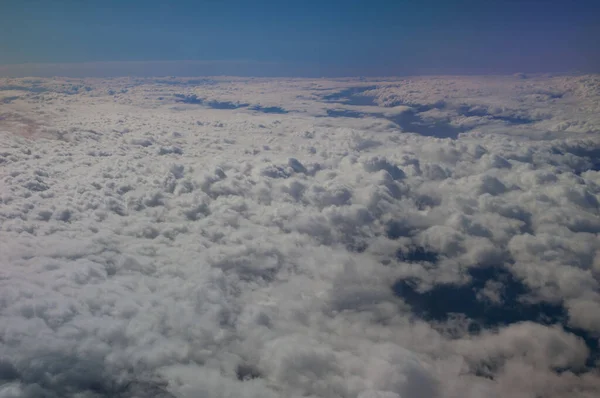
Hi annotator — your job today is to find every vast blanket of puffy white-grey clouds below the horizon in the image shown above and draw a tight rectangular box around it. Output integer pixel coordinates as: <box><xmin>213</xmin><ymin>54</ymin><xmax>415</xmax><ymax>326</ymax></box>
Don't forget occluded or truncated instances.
<box><xmin>0</xmin><ymin>76</ymin><xmax>600</xmax><ymax>398</ymax></box>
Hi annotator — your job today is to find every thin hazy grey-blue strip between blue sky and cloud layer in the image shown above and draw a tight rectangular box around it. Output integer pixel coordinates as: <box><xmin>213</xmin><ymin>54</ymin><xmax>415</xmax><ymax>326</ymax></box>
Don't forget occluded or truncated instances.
<box><xmin>0</xmin><ymin>59</ymin><xmax>600</xmax><ymax>78</ymax></box>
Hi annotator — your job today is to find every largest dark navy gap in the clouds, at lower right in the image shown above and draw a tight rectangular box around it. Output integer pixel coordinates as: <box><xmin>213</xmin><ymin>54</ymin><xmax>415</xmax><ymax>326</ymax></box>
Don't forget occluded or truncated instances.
<box><xmin>392</xmin><ymin>268</ymin><xmax>600</xmax><ymax>368</ymax></box>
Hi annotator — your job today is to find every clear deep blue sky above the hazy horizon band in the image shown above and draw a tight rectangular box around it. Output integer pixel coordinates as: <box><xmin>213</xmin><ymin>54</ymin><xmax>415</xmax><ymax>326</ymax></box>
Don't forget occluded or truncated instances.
<box><xmin>0</xmin><ymin>0</ymin><xmax>600</xmax><ymax>75</ymax></box>
